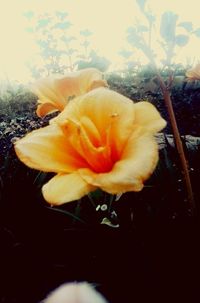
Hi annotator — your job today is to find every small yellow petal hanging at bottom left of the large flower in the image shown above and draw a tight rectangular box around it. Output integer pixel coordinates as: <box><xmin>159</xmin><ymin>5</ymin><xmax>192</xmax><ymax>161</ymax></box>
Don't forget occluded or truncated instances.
<box><xmin>42</xmin><ymin>172</ymin><xmax>96</xmax><ymax>205</ymax></box>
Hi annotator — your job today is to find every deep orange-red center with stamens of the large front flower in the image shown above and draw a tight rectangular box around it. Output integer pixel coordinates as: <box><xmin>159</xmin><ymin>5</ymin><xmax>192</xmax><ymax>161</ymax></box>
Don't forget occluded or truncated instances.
<box><xmin>60</xmin><ymin>114</ymin><xmax>117</xmax><ymax>173</ymax></box>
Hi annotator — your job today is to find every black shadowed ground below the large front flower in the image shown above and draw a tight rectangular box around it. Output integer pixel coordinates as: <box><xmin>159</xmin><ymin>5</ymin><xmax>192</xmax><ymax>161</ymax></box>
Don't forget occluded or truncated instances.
<box><xmin>0</xmin><ymin>181</ymin><xmax>200</xmax><ymax>303</ymax></box>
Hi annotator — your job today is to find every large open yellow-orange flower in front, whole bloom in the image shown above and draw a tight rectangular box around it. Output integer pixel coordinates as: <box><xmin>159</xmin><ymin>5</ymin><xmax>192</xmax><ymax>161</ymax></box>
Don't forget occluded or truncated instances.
<box><xmin>15</xmin><ymin>88</ymin><xmax>166</xmax><ymax>205</ymax></box>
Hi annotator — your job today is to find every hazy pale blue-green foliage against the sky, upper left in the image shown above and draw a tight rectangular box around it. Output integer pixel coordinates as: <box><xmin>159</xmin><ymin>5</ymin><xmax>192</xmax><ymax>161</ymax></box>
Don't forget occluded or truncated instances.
<box><xmin>25</xmin><ymin>12</ymin><xmax>109</xmax><ymax>78</ymax></box>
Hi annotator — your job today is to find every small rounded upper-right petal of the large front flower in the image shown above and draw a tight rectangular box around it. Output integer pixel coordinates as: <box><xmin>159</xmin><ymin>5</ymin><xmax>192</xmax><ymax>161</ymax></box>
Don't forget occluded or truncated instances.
<box><xmin>134</xmin><ymin>101</ymin><xmax>166</xmax><ymax>133</ymax></box>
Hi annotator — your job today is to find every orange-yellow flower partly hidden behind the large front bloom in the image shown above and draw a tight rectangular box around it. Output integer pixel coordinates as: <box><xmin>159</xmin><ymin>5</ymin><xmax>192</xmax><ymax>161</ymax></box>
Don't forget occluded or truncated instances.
<box><xmin>32</xmin><ymin>68</ymin><xmax>107</xmax><ymax>117</ymax></box>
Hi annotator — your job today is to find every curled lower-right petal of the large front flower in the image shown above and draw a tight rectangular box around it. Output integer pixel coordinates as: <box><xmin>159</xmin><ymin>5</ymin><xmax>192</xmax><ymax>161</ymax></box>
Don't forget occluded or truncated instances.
<box><xmin>79</xmin><ymin>134</ymin><xmax>158</xmax><ymax>194</ymax></box>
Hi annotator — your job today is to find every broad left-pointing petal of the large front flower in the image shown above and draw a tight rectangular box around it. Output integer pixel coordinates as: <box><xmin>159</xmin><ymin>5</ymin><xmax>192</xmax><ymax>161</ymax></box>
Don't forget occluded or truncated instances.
<box><xmin>15</xmin><ymin>124</ymin><xmax>88</xmax><ymax>173</ymax></box>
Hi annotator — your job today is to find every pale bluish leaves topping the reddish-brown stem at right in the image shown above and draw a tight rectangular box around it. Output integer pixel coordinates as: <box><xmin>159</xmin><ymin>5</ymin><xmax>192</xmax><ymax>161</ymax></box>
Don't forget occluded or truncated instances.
<box><xmin>127</xmin><ymin>0</ymin><xmax>200</xmax><ymax>67</ymax></box>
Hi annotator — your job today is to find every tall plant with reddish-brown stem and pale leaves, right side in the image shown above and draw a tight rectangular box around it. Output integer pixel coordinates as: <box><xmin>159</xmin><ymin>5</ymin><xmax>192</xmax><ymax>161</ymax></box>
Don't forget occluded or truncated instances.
<box><xmin>125</xmin><ymin>1</ymin><xmax>198</xmax><ymax>212</ymax></box>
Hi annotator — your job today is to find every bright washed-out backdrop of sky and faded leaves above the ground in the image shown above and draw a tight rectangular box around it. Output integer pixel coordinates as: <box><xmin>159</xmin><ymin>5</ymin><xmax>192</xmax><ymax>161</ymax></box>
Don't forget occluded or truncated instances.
<box><xmin>0</xmin><ymin>0</ymin><xmax>200</xmax><ymax>83</ymax></box>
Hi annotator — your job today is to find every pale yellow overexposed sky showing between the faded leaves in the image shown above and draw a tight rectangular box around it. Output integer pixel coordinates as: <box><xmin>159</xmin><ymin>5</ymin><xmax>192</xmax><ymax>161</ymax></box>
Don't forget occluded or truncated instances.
<box><xmin>0</xmin><ymin>0</ymin><xmax>200</xmax><ymax>81</ymax></box>
